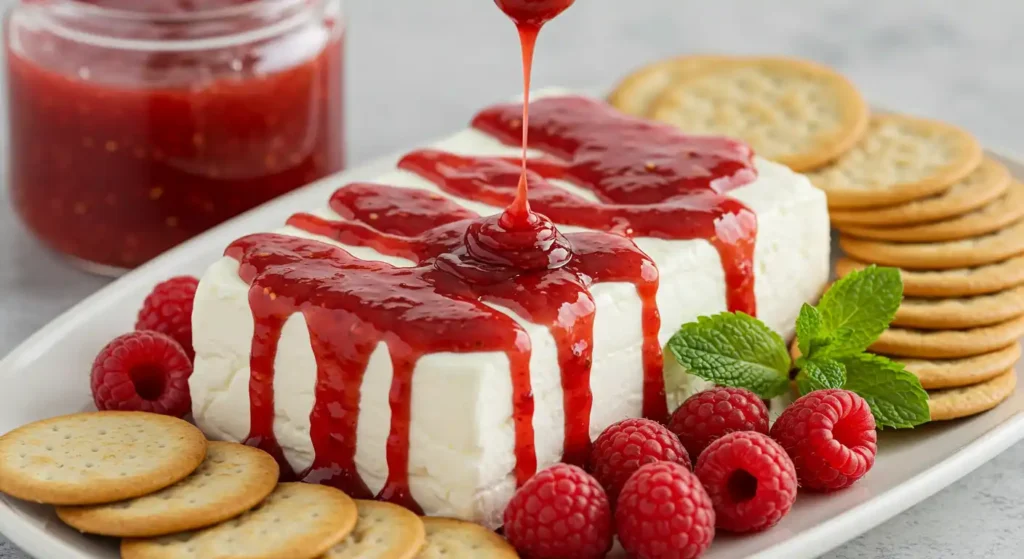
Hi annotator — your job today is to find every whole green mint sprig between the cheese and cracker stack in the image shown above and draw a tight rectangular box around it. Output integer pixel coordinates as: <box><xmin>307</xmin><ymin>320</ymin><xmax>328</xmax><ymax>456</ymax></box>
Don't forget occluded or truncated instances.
<box><xmin>668</xmin><ymin>266</ymin><xmax>929</xmax><ymax>428</ymax></box>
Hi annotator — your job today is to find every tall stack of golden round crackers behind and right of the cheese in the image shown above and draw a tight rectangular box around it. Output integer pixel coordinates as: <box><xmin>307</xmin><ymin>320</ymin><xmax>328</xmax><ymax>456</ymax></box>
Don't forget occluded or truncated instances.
<box><xmin>609</xmin><ymin>55</ymin><xmax>1024</xmax><ymax>420</ymax></box>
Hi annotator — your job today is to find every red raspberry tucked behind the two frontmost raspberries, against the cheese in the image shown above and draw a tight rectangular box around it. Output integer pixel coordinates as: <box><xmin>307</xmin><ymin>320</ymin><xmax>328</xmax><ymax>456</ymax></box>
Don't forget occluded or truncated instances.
<box><xmin>590</xmin><ymin>419</ymin><xmax>691</xmax><ymax>503</ymax></box>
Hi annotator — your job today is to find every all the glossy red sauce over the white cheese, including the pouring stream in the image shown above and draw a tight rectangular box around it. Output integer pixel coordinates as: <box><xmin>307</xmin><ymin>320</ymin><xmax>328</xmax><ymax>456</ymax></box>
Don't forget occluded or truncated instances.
<box><xmin>226</xmin><ymin>0</ymin><xmax>757</xmax><ymax>511</ymax></box>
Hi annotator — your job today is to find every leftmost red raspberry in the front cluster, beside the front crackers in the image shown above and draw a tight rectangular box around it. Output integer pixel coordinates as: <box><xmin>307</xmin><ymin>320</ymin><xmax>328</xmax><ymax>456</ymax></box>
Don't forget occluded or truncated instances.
<box><xmin>505</xmin><ymin>464</ymin><xmax>611</xmax><ymax>559</ymax></box>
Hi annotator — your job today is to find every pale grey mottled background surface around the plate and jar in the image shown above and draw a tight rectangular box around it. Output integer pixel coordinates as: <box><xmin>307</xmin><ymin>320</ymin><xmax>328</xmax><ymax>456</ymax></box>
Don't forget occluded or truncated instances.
<box><xmin>0</xmin><ymin>0</ymin><xmax>1024</xmax><ymax>559</ymax></box>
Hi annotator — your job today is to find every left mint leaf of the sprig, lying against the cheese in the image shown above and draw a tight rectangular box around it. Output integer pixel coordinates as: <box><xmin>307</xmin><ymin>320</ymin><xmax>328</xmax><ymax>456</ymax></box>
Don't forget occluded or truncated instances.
<box><xmin>668</xmin><ymin>312</ymin><xmax>790</xmax><ymax>398</ymax></box>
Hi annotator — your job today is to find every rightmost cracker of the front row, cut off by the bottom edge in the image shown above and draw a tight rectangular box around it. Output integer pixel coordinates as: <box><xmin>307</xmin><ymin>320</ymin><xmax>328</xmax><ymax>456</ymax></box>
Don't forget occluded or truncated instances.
<box><xmin>416</xmin><ymin>517</ymin><xmax>519</xmax><ymax>559</ymax></box>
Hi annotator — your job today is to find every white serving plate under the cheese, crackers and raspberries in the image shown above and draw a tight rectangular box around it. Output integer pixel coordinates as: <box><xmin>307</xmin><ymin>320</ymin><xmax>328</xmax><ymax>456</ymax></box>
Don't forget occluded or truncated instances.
<box><xmin>0</xmin><ymin>128</ymin><xmax>1024</xmax><ymax>559</ymax></box>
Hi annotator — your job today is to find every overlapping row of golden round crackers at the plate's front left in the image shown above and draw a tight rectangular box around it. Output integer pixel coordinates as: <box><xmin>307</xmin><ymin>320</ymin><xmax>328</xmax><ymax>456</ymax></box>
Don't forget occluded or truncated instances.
<box><xmin>0</xmin><ymin>412</ymin><xmax>518</xmax><ymax>559</ymax></box>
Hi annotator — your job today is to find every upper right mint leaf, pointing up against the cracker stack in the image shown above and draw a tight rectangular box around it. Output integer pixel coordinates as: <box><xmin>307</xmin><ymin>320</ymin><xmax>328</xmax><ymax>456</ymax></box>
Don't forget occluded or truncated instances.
<box><xmin>801</xmin><ymin>265</ymin><xmax>903</xmax><ymax>358</ymax></box>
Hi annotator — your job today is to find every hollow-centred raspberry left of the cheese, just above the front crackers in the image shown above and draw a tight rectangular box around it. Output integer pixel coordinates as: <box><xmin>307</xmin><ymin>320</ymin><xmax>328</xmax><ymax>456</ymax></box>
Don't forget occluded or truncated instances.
<box><xmin>92</xmin><ymin>331</ymin><xmax>191</xmax><ymax>418</ymax></box>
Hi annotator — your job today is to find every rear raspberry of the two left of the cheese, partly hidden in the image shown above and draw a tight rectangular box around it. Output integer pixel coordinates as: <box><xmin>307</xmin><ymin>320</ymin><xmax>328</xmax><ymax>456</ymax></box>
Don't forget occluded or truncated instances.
<box><xmin>135</xmin><ymin>275</ymin><xmax>199</xmax><ymax>359</ymax></box>
